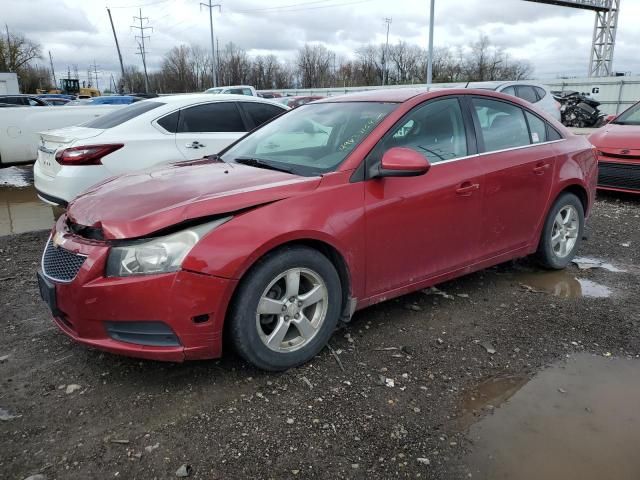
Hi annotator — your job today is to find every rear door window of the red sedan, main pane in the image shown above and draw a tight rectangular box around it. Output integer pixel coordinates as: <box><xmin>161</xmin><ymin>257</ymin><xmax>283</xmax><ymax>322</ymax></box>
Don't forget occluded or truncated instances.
<box><xmin>472</xmin><ymin>98</ymin><xmax>531</xmax><ymax>152</ymax></box>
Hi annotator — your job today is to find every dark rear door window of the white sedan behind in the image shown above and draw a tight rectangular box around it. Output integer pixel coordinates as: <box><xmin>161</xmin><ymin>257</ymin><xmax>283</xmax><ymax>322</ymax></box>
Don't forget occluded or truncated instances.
<box><xmin>178</xmin><ymin>102</ymin><xmax>247</xmax><ymax>133</ymax></box>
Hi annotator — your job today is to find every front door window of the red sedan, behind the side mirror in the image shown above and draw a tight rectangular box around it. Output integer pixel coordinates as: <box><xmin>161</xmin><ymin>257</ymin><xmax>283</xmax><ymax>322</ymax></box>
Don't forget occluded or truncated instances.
<box><xmin>373</xmin><ymin>98</ymin><xmax>468</xmax><ymax>164</ymax></box>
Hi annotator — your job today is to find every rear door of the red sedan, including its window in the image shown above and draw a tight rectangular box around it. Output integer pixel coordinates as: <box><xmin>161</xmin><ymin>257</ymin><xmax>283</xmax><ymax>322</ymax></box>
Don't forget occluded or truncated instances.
<box><xmin>471</xmin><ymin>97</ymin><xmax>556</xmax><ymax>258</ymax></box>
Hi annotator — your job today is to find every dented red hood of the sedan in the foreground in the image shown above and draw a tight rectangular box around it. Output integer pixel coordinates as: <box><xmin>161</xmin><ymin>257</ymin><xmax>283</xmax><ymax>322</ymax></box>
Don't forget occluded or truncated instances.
<box><xmin>67</xmin><ymin>160</ymin><xmax>320</xmax><ymax>240</ymax></box>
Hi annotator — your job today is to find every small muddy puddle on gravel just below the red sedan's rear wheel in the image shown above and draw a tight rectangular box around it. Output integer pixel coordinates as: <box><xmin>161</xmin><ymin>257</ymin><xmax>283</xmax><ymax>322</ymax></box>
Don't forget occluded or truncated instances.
<box><xmin>515</xmin><ymin>270</ymin><xmax>613</xmax><ymax>298</ymax></box>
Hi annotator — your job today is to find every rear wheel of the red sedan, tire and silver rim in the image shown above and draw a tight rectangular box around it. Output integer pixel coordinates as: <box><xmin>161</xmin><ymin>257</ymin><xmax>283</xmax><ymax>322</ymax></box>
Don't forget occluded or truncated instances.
<box><xmin>537</xmin><ymin>192</ymin><xmax>584</xmax><ymax>270</ymax></box>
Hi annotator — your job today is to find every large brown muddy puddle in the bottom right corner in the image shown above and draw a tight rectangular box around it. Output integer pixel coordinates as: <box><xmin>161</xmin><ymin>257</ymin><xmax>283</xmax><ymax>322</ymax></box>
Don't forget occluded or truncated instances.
<box><xmin>465</xmin><ymin>354</ymin><xmax>640</xmax><ymax>480</ymax></box>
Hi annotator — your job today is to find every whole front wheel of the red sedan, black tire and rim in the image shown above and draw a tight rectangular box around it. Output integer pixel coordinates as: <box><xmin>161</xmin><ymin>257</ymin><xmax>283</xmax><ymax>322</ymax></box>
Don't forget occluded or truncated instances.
<box><xmin>229</xmin><ymin>246</ymin><xmax>342</xmax><ymax>371</ymax></box>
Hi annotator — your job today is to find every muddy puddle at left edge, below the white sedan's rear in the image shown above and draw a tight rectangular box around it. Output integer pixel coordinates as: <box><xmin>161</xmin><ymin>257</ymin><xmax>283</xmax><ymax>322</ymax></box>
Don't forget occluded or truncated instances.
<box><xmin>0</xmin><ymin>167</ymin><xmax>62</xmax><ymax>236</ymax></box>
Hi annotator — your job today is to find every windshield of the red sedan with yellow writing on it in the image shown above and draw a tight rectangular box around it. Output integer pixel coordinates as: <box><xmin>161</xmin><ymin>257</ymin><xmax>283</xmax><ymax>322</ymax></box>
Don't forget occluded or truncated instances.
<box><xmin>222</xmin><ymin>102</ymin><xmax>397</xmax><ymax>176</ymax></box>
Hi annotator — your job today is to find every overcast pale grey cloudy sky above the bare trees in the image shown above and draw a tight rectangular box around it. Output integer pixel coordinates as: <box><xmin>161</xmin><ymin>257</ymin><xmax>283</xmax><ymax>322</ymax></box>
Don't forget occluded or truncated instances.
<box><xmin>0</xmin><ymin>0</ymin><xmax>640</xmax><ymax>88</ymax></box>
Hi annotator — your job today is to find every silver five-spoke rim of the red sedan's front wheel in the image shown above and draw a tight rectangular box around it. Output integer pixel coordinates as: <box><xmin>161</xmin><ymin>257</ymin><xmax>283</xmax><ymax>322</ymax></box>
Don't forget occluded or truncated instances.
<box><xmin>256</xmin><ymin>268</ymin><xmax>329</xmax><ymax>353</ymax></box>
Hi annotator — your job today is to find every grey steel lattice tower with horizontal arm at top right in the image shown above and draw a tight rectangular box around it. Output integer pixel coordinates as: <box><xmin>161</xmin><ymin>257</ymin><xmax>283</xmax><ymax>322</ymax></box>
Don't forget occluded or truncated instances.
<box><xmin>525</xmin><ymin>0</ymin><xmax>620</xmax><ymax>77</ymax></box>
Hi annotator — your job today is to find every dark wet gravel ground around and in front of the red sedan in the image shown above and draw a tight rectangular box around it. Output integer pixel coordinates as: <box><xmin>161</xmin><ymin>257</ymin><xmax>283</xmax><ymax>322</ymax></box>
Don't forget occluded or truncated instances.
<box><xmin>0</xmin><ymin>195</ymin><xmax>640</xmax><ymax>479</ymax></box>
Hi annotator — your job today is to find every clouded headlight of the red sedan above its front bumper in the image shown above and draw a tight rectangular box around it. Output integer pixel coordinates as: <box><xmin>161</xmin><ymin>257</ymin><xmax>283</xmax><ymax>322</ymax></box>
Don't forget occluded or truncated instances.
<box><xmin>107</xmin><ymin>217</ymin><xmax>231</xmax><ymax>277</ymax></box>
